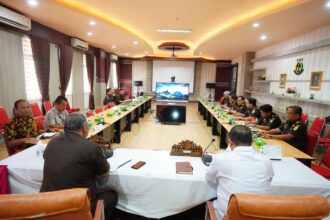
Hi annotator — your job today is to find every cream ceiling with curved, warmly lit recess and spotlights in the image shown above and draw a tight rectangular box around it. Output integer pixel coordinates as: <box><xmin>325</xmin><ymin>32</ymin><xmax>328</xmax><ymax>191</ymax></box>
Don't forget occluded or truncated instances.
<box><xmin>0</xmin><ymin>0</ymin><xmax>330</xmax><ymax>59</ymax></box>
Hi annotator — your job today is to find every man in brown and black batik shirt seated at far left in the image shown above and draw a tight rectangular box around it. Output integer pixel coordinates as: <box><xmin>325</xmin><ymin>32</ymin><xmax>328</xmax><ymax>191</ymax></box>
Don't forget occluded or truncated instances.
<box><xmin>4</xmin><ymin>99</ymin><xmax>39</xmax><ymax>152</ymax></box>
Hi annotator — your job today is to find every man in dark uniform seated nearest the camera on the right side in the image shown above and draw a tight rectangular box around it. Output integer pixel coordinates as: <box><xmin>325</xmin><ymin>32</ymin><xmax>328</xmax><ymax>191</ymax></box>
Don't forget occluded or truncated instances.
<box><xmin>264</xmin><ymin>106</ymin><xmax>307</xmax><ymax>152</ymax></box>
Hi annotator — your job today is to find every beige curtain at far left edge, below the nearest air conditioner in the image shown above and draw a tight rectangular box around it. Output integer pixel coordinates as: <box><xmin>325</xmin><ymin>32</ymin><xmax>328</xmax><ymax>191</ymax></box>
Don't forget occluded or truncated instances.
<box><xmin>0</xmin><ymin>30</ymin><xmax>26</xmax><ymax>117</ymax></box>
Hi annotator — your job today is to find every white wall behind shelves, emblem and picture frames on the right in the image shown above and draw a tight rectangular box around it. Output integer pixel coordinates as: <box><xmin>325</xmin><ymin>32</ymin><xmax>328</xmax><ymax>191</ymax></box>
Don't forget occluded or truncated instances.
<box><xmin>254</xmin><ymin>26</ymin><xmax>330</xmax><ymax>117</ymax></box>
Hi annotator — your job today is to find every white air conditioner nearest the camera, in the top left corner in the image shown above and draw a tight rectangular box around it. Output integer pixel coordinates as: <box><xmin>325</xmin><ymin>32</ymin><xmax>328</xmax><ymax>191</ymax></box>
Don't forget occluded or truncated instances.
<box><xmin>0</xmin><ymin>6</ymin><xmax>31</xmax><ymax>31</ymax></box>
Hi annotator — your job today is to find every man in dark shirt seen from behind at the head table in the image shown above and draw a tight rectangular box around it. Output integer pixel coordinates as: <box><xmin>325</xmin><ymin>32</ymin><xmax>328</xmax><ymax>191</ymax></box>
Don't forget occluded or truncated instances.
<box><xmin>40</xmin><ymin>112</ymin><xmax>117</xmax><ymax>219</ymax></box>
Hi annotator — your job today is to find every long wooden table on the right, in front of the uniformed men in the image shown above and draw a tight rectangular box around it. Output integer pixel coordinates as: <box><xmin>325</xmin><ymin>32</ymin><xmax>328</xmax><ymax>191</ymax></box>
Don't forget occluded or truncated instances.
<box><xmin>198</xmin><ymin>100</ymin><xmax>314</xmax><ymax>167</ymax></box>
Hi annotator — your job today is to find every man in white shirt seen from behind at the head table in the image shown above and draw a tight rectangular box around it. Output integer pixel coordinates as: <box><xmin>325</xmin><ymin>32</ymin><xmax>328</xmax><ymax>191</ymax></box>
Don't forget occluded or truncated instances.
<box><xmin>206</xmin><ymin>125</ymin><xmax>274</xmax><ymax>220</ymax></box>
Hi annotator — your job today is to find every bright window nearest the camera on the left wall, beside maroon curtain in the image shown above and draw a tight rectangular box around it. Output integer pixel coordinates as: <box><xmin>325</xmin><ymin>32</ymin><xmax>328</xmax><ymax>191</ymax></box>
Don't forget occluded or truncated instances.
<box><xmin>22</xmin><ymin>36</ymin><xmax>41</xmax><ymax>101</ymax></box>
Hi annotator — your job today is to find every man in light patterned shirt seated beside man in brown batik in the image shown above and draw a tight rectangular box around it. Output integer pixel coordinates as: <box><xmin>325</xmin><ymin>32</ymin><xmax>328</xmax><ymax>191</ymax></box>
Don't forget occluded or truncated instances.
<box><xmin>45</xmin><ymin>96</ymin><xmax>69</xmax><ymax>129</ymax></box>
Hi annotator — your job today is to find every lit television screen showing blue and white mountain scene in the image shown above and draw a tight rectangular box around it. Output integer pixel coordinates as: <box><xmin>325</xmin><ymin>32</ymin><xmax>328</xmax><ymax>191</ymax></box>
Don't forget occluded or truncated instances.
<box><xmin>156</xmin><ymin>82</ymin><xmax>189</xmax><ymax>102</ymax></box>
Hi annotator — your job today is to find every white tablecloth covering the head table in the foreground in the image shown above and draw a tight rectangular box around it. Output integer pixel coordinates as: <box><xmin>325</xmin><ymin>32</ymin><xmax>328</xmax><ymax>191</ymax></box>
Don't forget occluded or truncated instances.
<box><xmin>0</xmin><ymin>146</ymin><xmax>330</xmax><ymax>218</ymax></box>
